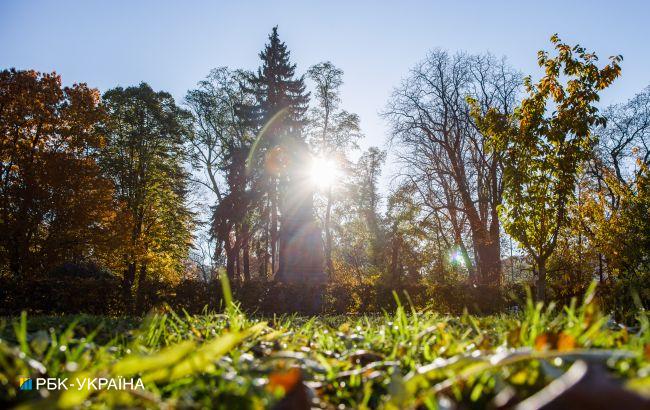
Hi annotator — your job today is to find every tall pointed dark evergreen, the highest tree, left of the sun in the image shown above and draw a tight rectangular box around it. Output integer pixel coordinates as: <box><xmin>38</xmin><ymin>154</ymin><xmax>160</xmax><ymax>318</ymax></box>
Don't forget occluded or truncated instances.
<box><xmin>240</xmin><ymin>26</ymin><xmax>323</xmax><ymax>280</ymax></box>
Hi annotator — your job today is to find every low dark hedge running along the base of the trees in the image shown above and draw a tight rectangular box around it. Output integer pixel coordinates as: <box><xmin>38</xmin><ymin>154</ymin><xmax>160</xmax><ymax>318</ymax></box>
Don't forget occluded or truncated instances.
<box><xmin>0</xmin><ymin>265</ymin><xmax>612</xmax><ymax>320</ymax></box>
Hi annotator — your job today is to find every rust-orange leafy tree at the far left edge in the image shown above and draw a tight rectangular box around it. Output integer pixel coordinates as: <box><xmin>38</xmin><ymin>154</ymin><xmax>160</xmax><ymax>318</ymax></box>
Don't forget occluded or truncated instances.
<box><xmin>0</xmin><ymin>69</ymin><xmax>114</xmax><ymax>279</ymax></box>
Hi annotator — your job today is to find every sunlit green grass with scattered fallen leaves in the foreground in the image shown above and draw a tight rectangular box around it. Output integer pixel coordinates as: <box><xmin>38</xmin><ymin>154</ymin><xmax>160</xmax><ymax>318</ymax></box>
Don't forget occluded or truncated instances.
<box><xmin>0</xmin><ymin>286</ymin><xmax>650</xmax><ymax>409</ymax></box>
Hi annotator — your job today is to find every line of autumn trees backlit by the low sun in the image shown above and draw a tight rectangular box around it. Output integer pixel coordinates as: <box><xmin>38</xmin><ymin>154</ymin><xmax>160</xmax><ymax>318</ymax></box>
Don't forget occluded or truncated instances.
<box><xmin>0</xmin><ymin>27</ymin><xmax>650</xmax><ymax>318</ymax></box>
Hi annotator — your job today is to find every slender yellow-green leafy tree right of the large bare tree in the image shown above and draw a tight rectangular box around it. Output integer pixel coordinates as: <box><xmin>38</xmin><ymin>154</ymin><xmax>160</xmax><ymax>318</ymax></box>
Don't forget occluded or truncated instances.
<box><xmin>472</xmin><ymin>35</ymin><xmax>621</xmax><ymax>300</ymax></box>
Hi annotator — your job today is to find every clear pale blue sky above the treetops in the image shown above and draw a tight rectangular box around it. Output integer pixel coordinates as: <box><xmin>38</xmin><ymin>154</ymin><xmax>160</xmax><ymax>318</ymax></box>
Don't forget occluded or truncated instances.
<box><xmin>0</xmin><ymin>0</ymin><xmax>650</xmax><ymax>187</ymax></box>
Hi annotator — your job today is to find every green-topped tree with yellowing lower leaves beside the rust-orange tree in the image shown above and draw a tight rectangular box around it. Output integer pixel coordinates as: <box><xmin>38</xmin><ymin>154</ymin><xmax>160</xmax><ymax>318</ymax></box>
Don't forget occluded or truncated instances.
<box><xmin>101</xmin><ymin>83</ymin><xmax>192</xmax><ymax>309</ymax></box>
